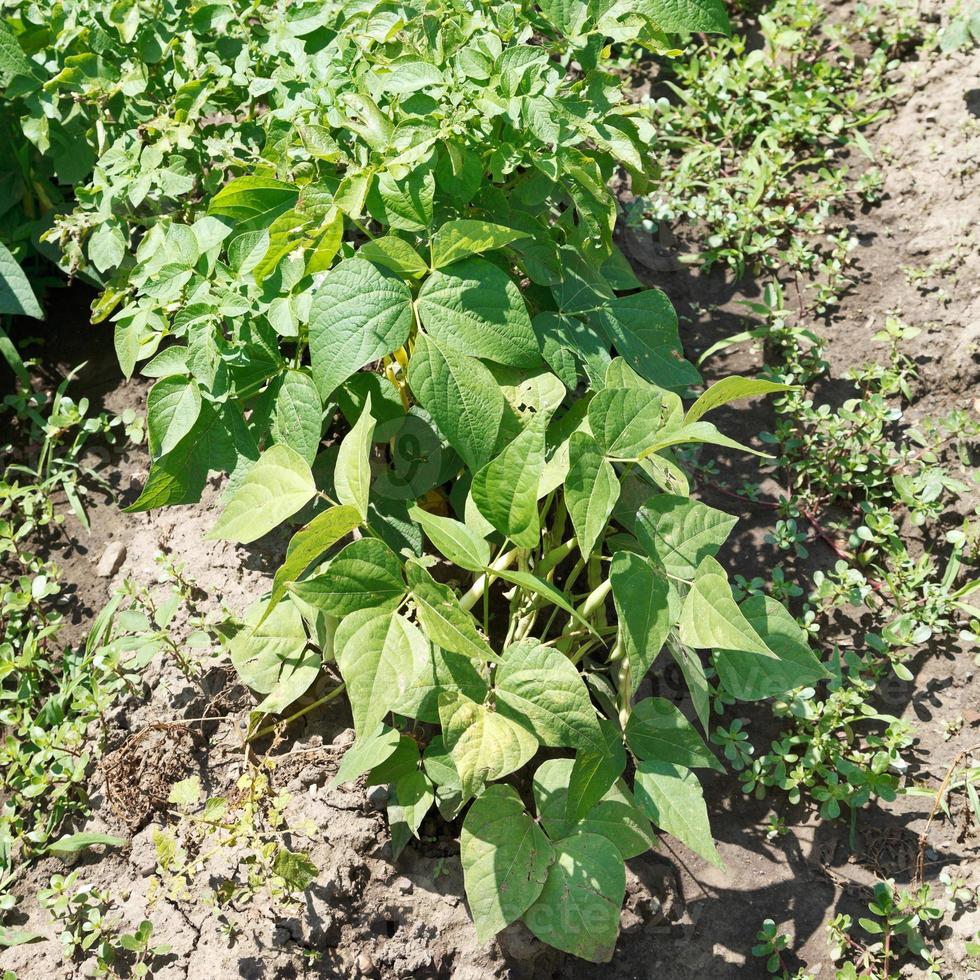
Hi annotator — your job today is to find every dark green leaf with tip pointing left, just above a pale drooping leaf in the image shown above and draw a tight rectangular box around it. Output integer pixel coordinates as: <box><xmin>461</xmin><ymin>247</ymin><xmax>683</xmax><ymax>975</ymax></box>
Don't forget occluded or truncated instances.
<box><xmin>289</xmin><ymin>538</ymin><xmax>405</xmax><ymax>619</ymax></box>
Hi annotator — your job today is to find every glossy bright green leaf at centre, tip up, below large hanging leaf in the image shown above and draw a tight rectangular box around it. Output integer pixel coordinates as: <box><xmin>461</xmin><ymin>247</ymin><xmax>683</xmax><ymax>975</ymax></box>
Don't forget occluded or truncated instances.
<box><xmin>470</xmin><ymin>412</ymin><xmax>548</xmax><ymax>548</ymax></box>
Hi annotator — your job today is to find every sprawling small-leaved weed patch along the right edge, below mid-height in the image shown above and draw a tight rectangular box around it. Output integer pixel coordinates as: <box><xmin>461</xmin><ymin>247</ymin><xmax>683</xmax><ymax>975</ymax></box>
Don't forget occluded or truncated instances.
<box><xmin>700</xmin><ymin>286</ymin><xmax>980</xmax><ymax>828</ymax></box>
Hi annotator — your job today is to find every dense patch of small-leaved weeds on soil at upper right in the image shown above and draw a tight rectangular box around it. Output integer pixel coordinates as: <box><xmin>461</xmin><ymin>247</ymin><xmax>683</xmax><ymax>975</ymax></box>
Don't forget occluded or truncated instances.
<box><xmin>629</xmin><ymin>0</ymin><xmax>923</xmax><ymax>313</ymax></box>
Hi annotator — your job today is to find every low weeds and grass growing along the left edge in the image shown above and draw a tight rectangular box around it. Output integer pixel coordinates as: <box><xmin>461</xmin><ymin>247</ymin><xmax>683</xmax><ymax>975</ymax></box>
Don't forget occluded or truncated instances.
<box><xmin>0</xmin><ymin>368</ymin><xmax>165</xmax><ymax>912</ymax></box>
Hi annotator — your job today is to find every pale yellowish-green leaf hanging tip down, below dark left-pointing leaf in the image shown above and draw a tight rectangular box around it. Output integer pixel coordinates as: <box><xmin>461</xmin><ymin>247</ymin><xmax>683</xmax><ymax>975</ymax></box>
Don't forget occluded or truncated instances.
<box><xmin>334</xmin><ymin>609</ymin><xmax>429</xmax><ymax>738</ymax></box>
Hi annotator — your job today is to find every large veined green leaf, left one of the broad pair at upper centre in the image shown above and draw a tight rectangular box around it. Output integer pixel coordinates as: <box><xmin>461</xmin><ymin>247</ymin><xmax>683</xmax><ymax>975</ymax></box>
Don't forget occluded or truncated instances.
<box><xmin>310</xmin><ymin>257</ymin><xmax>414</xmax><ymax>400</ymax></box>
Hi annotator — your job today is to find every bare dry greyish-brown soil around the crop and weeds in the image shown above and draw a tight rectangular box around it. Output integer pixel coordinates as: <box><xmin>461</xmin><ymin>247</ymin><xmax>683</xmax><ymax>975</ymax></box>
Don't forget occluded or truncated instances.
<box><xmin>0</xmin><ymin>9</ymin><xmax>980</xmax><ymax>980</ymax></box>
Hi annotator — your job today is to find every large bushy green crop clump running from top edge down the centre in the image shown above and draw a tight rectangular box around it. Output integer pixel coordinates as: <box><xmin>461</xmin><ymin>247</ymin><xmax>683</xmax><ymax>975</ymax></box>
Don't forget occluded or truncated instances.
<box><xmin>5</xmin><ymin>0</ymin><xmax>836</xmax><ymax>961</ymax></box>
